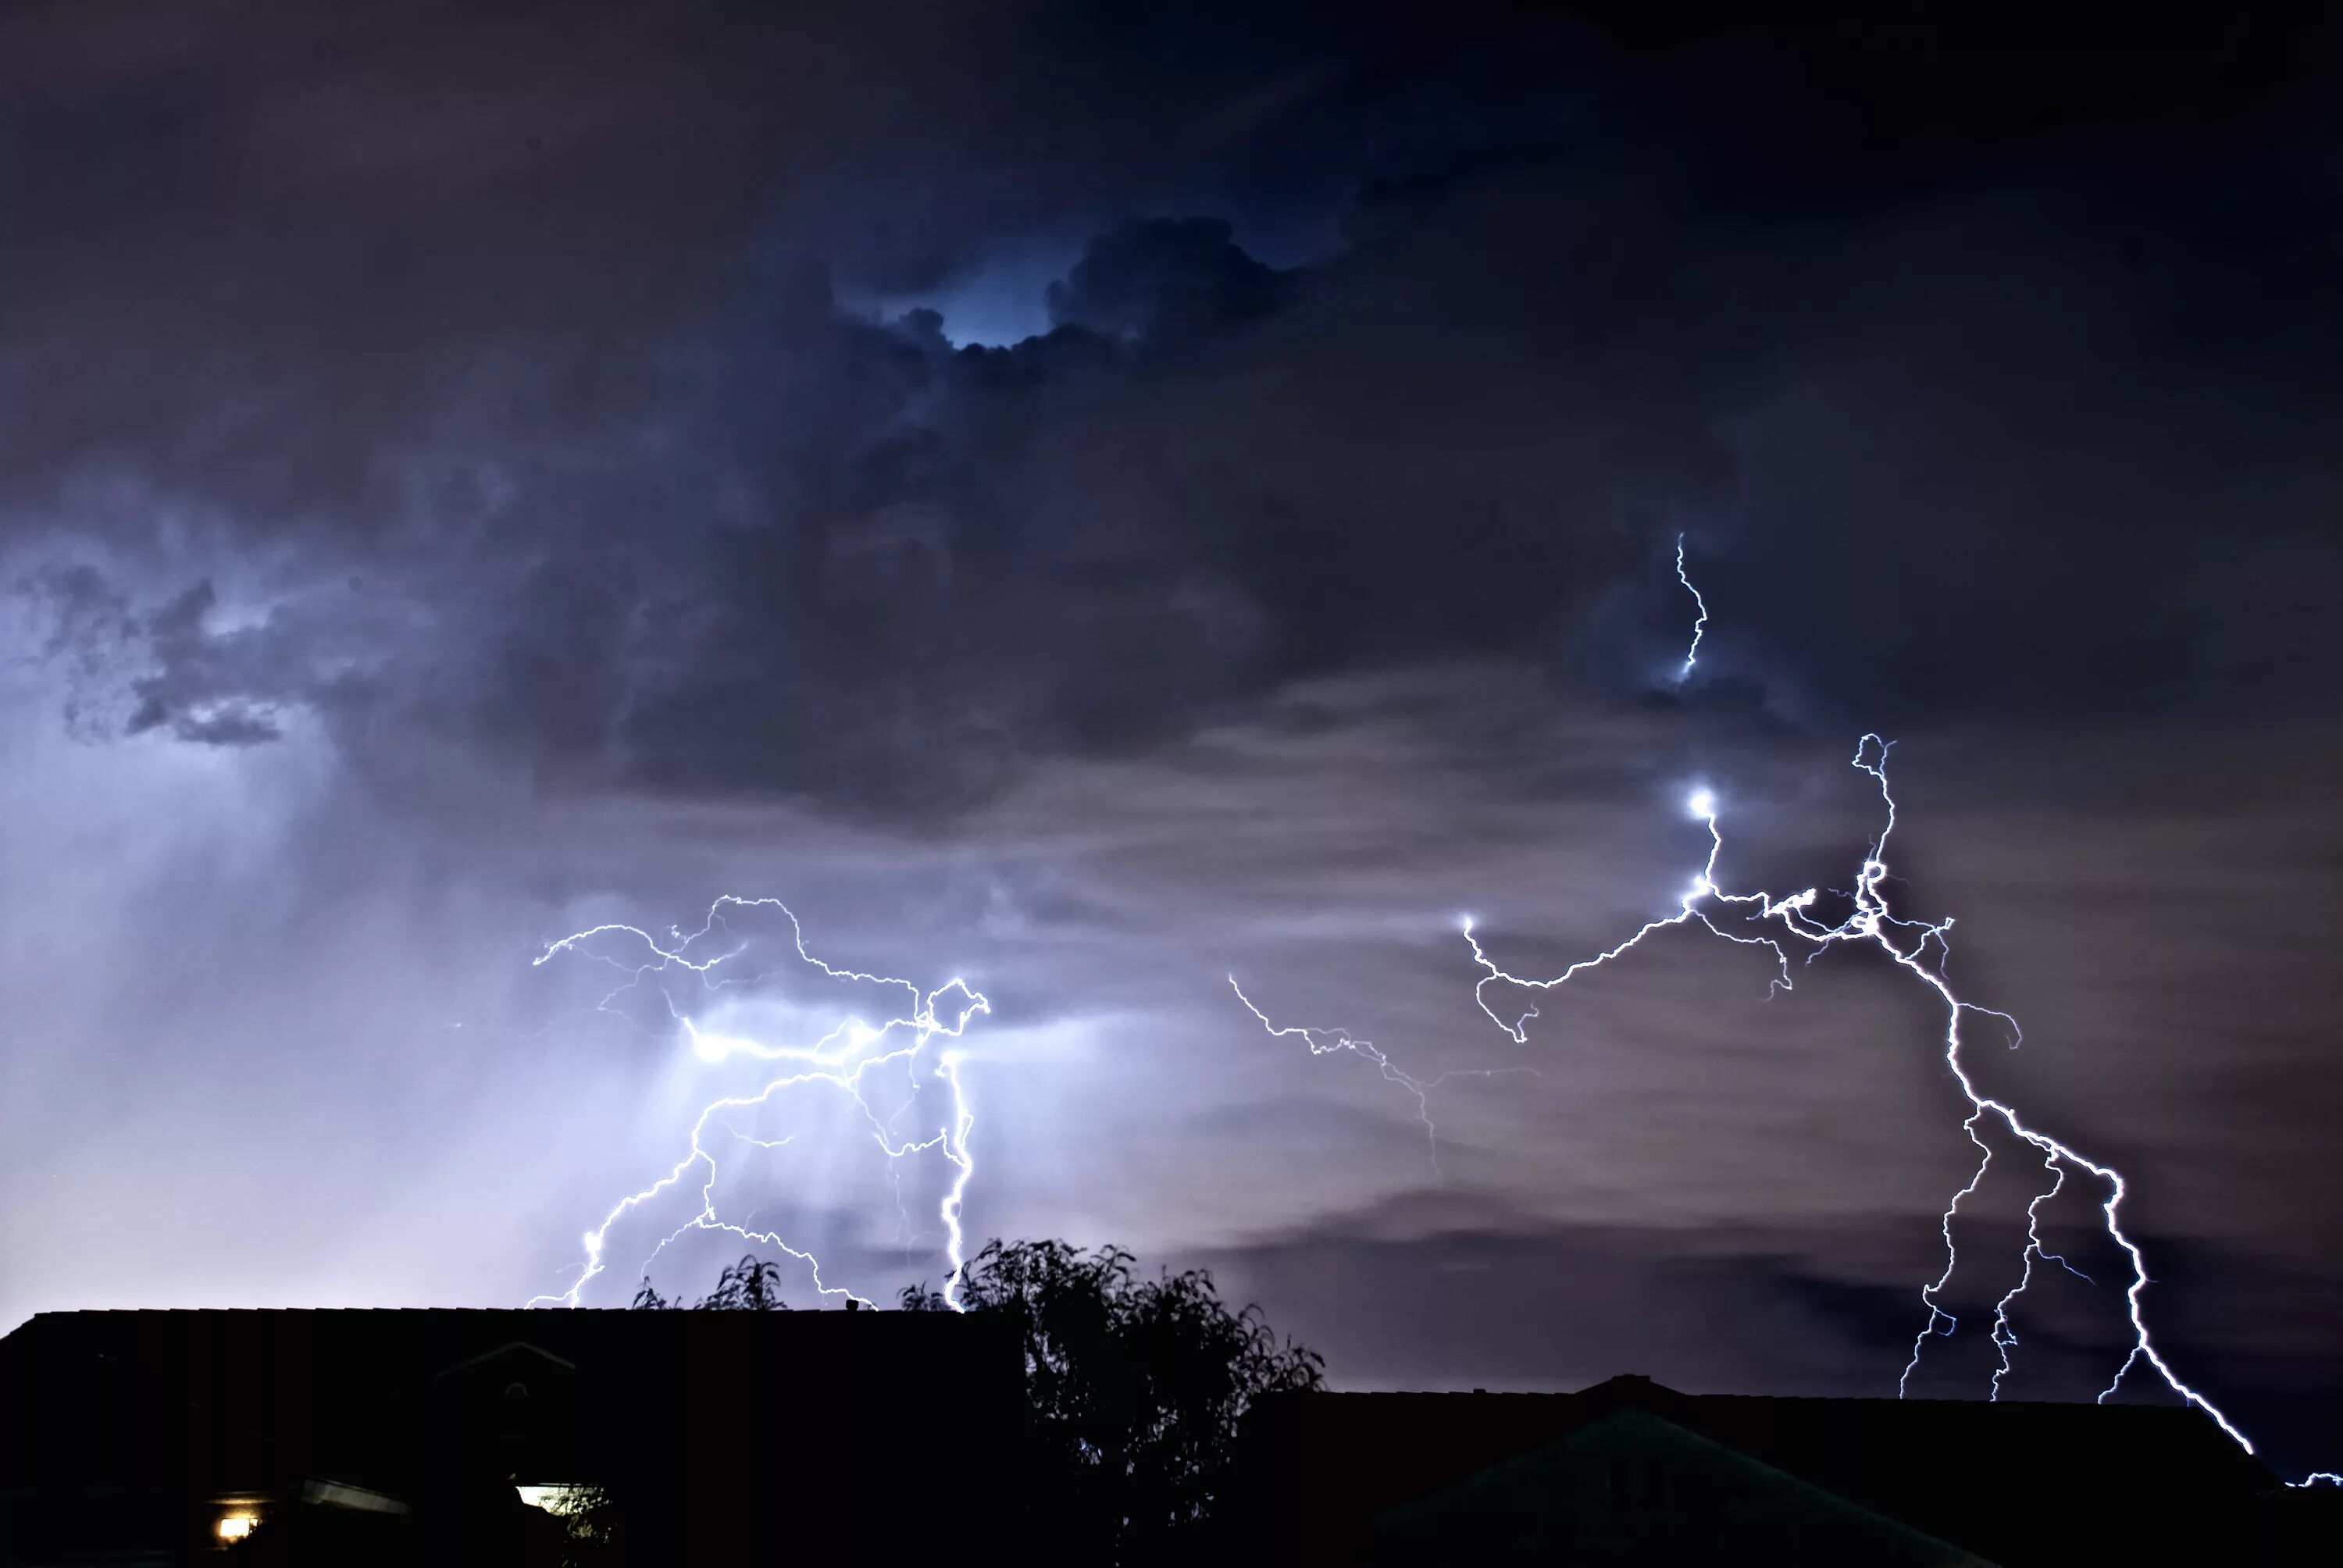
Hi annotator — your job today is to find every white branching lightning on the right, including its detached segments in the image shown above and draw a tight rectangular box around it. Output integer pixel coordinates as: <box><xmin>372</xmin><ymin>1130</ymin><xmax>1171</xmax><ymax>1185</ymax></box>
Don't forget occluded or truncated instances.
<box><xmin>1230</xmin><ymin>534</ymin><xmax>2343</xmax><ymax>1486</ymax></box>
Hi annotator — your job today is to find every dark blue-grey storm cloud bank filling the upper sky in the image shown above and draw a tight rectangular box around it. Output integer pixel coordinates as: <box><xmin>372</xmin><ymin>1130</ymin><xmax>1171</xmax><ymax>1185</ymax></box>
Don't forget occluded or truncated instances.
<box><xmin>7</xmin><ymin>9</ymin><xmax>2343</xmax><ymax>814</ymax></box>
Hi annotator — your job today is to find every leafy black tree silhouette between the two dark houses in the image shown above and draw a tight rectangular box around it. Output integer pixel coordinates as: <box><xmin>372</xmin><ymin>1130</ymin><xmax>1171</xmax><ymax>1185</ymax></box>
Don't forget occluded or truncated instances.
<box><xmin>902</xmin><ymin>1240</ymin><xmax>1326</xmax><ymax>1561</ymax></box>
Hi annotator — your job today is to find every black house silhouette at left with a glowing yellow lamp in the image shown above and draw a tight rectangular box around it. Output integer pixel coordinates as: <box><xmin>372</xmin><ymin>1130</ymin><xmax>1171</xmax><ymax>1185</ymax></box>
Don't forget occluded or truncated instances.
<box><xmin>0</xmin><ymin>1310</ymin><xmax>1024</xmax><ymax>1566</ymax></box>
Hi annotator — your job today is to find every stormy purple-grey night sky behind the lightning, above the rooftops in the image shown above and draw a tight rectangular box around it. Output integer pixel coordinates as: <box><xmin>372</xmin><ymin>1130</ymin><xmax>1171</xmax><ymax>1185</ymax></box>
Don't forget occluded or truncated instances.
<box><xmin>0</xmin><ymin>0</ymin><xmax>2343</xmax><ymax>1474</ymax></box>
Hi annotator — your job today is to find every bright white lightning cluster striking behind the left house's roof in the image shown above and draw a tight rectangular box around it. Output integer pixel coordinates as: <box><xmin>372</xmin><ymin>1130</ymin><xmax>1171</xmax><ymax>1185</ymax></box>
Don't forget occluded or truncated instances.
<box><xmin>530</xmin><ymin>893</ymin><xmax>991</xmax><ymax>1310</ymax></box>
